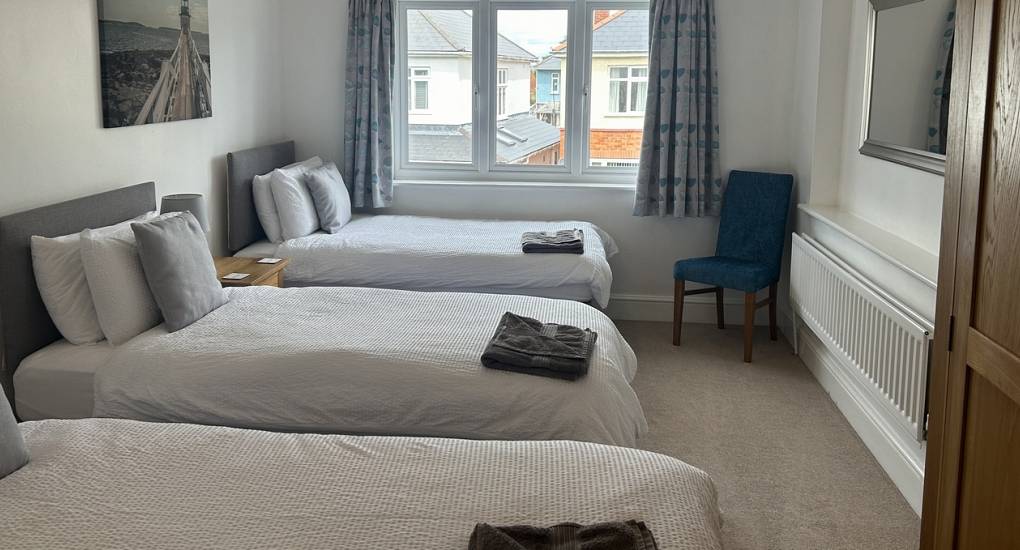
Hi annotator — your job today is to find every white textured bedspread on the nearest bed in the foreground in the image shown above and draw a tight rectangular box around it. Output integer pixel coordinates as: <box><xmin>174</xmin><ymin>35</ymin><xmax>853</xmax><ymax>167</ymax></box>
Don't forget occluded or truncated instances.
<box><xmin>0</xmin><ymin>419</ymin><xmax>721</xmax><ymax>550</ymax></box>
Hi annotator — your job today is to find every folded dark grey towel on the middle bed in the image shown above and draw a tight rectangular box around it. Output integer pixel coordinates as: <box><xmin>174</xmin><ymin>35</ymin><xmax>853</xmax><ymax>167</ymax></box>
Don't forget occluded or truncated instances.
<box><xmin>481</xmin><ymin>312</ymin><xmax>599</xmax><ymax>380</ymax></box>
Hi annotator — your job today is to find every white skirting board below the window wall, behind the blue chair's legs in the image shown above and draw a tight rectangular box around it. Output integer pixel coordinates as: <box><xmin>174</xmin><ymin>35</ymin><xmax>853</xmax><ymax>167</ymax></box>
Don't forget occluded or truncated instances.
<box><xmin>606</xmin><ymin>294</ymin><xmax>768</xmax><ymax>327</ymax></box>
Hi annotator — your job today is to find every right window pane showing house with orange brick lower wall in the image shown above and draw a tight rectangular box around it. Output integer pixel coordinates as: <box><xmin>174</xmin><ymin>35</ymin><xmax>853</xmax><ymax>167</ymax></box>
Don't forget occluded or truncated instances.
<box><xmin>589</xmin><ymin>9</ymin><xmax>648</xmax><ymax>167</ymax></box>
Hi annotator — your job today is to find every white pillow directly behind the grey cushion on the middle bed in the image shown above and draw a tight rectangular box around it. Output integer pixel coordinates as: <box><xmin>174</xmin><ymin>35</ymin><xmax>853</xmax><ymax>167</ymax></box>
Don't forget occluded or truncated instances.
<box><xmin>82</xmin><ymin>218</ymin><xmax>167</xmax><ymax>346</ymax></box>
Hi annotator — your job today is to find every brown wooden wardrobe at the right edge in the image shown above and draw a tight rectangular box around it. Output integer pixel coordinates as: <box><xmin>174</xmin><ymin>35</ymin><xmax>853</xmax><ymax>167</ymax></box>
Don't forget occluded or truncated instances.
<box><xmin>921</xmin><ymin>0</ymin><xmax>1020</xmax><ymax>549</ymax></box>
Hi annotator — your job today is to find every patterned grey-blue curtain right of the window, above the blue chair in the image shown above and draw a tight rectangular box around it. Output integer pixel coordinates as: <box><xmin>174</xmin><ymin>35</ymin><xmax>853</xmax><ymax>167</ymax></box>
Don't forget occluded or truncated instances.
<box><xmin>634</xmin><ymin>0</ymin><xmax>722</xmax><ymax>217</ymax></box>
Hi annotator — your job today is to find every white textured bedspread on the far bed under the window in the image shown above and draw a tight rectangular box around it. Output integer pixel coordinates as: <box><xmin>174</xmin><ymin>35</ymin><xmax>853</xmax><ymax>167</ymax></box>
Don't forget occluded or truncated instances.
<box><xmin>276</xmin><ymin>215</ymin><xmax>616</xmax><ymax>307</ymax></box>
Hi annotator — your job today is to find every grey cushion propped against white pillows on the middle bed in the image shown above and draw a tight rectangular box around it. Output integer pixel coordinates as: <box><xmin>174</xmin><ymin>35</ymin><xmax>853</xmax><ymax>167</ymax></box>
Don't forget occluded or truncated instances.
<box><xmin>132</xmin><ymin>212</ymin><xmax>226</xmax><ymax>333</ymax></box>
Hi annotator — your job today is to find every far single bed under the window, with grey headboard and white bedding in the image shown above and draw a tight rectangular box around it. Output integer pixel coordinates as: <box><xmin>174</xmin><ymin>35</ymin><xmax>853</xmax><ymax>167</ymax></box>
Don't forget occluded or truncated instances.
<box><xmin>227</xmin><ymin>142</ymin><xmax>617</xmax><ymax>307</ymax></box>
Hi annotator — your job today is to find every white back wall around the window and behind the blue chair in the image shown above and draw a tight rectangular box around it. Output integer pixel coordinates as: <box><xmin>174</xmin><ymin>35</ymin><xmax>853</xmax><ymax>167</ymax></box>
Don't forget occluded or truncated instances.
<box><xmin>281</xmin><ymin>0</ymin><xmax>799</xmax><ymax>312</ymax></box>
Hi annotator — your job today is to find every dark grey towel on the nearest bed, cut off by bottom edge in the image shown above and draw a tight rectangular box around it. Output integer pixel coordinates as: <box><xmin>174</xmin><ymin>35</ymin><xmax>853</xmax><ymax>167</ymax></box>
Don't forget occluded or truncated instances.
<box><xmin>468</xmin><ymin>521</ymin><xmax>659</xmax><ymax>550</ymax></box>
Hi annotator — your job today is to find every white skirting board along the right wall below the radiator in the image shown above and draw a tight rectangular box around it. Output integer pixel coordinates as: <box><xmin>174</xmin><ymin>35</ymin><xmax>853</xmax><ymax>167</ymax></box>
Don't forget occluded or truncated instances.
<box><xmin>784</xmin><ymin>326</ymin><xmax>924</xmax><ymax>515</ymax></box>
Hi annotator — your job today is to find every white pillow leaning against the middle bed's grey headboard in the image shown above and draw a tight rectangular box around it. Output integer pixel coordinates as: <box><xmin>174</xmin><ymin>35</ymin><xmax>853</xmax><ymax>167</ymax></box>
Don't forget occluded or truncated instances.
<box><xmin>32</xmin><ymin>212</ymin><xmax>156</xmax><ymax>344</ymax></box>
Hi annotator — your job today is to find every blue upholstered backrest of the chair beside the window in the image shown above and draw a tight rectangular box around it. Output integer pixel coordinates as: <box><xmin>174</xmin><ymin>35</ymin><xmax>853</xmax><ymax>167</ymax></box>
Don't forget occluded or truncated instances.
<box><xmin>715</xmin><ymin>170</ymin><xmax>794</xmax><ymax>281</ymax></box>
